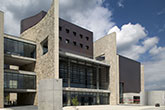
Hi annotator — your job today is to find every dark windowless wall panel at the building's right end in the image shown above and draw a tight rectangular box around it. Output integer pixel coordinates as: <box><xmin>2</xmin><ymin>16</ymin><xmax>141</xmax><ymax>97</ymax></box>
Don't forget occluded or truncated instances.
<box><xmin>119</xmin><ymin>55</ymin><xmax>141</xmax><ymax>93</ymax></box>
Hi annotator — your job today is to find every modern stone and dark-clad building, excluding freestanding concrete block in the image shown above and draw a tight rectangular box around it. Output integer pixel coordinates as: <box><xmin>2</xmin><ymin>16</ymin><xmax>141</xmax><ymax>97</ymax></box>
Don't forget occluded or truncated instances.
<box><xmin>0</xmin><ymin>0</ymin><xmax>144</xmax><ymax>107</ymax></box>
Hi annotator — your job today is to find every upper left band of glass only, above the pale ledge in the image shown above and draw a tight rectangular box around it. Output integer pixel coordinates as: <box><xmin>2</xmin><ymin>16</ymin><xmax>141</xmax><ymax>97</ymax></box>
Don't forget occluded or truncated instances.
<box><xmin>4</xmin><ymin>38</ymin><xmax>36</xmax><ymax>58</ymax></box>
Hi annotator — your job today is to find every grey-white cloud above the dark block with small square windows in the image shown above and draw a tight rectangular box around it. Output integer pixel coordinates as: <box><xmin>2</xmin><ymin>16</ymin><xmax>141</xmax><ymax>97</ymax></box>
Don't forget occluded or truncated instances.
<box><xmin>60</xmin><ymin>0</ymin><xmax>115</xmax><ymax>40</ymax></box>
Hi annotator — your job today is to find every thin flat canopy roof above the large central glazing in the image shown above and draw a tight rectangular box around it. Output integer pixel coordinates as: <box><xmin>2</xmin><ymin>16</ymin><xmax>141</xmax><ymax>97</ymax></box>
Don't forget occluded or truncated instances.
<box><xmin>59</xmin><ymin>51</ymin><xmax>110</xmax><ymax>67</ymax></box>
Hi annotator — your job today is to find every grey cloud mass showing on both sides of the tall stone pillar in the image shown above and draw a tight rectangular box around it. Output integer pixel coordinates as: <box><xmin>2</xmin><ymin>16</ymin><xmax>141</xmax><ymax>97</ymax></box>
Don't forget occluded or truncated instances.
<box><xmin>0</xmin><ymin>0</ymin><xmax>115</xmax><ymax>40</ymax></box>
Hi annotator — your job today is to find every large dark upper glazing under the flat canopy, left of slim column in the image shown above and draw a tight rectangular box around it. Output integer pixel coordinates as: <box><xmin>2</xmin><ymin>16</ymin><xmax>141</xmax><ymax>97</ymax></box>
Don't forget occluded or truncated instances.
<box><xmin>60</xmin><ymin>58</ymin><xmax>97</xmax><ymax>89</ymax></box>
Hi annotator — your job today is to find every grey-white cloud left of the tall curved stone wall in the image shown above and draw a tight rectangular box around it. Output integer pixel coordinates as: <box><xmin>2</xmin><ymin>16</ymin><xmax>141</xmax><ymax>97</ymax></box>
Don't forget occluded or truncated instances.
<box><xmin>0</xmin><ymin>0</ymin><xmax>52</xmax><ymax>36</ymax></box>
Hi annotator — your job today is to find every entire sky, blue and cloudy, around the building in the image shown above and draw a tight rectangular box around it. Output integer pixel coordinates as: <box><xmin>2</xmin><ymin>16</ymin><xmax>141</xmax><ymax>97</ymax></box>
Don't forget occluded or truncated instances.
<box><xmin>0</xmin><ymin>0</ymin><xmax>165</xmax><ymax>90</ymax></box>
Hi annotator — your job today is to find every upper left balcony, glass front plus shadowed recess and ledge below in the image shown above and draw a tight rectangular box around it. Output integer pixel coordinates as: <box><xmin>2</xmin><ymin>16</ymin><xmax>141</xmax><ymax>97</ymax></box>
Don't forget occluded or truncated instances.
<box><xmin>4</xmin><ymin>37</ymin><xmax>36</xmax><ymax>66</ymax></box>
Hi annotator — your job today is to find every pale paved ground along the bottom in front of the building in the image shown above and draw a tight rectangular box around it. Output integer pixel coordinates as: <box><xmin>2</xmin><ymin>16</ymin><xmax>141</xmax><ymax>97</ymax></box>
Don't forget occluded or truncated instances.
<box><xmin>0</xmin><ymin>105</ymin><xmax>165</xmax><ymax>110</ymax></box>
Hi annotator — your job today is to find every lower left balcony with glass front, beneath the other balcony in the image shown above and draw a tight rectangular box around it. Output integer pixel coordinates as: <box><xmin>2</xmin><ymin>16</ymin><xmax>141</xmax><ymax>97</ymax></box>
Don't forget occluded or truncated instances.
<box><xmin>4</xmin><ymin>70</ymin><xmax>36</xmax><ymax>92</ymax></box>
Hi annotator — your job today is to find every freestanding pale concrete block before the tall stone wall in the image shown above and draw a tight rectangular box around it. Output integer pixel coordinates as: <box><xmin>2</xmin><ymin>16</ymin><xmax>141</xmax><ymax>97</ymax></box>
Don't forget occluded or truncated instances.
<box><xmin>38</xmin><ymin>79</ymin><xmax>62</xmax><ymax>110</ymax></box>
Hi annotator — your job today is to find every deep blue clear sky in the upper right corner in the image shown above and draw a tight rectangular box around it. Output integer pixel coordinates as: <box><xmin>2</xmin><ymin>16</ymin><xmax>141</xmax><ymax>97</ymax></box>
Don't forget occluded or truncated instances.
<box><xmin>104</xmin><ymin>0</ymin><xmax>165</xmax><ymax>46</ymax></box>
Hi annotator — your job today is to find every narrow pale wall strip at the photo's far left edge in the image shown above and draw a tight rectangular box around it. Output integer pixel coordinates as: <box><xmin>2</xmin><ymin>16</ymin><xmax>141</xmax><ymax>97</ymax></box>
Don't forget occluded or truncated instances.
<box><xmin>0</xmin><ymin>11</ymin><xmax>4</xmax><ymax>108</ymax></box>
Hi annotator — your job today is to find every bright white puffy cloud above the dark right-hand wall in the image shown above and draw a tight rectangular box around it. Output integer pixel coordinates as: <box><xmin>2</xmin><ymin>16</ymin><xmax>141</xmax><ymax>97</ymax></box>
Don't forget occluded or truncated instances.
<box><xmin>108</xmin><ymin>23</ymin><xmax>158</xmax><ymax>60</ymax></box>
